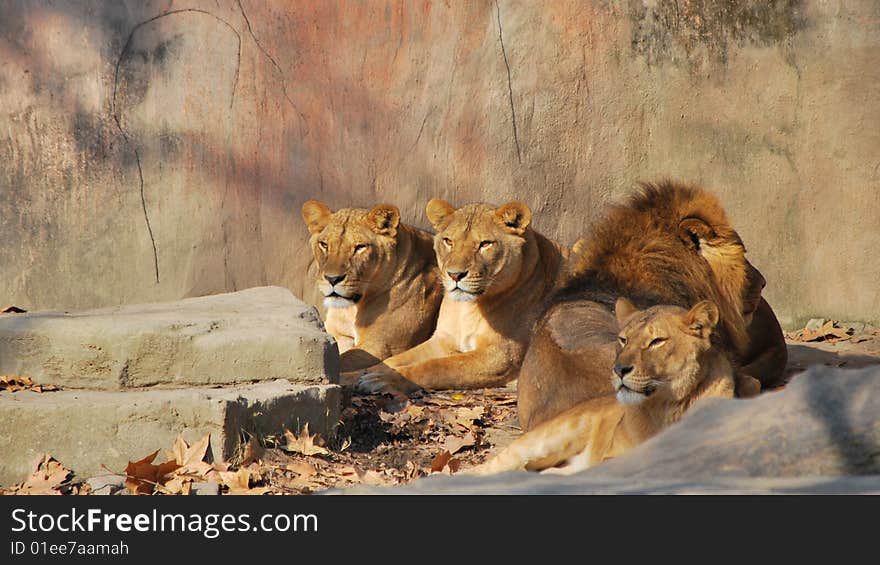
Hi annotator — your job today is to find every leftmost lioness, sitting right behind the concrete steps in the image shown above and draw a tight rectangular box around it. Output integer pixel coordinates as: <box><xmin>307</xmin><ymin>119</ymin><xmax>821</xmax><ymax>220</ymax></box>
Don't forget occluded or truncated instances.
<box><xmin>302</xmin><ymin>200</ymin><xmax>443</xmax><ymax>371</ymax></box>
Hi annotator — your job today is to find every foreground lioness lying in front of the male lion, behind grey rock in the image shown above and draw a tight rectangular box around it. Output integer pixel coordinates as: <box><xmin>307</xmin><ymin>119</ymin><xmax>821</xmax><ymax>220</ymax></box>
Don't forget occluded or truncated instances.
<box><xmin>468</xmin><ymin>298</ymin><xmax>735</xmax><ymax>475</ymax></box>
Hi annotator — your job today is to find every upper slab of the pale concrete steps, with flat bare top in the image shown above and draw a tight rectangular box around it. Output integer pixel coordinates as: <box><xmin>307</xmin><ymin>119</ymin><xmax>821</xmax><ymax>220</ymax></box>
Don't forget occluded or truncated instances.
<box><xmin>0</xmin><ymin>287</ymin><xmax>339</xmax><ymax>390</ymax></box>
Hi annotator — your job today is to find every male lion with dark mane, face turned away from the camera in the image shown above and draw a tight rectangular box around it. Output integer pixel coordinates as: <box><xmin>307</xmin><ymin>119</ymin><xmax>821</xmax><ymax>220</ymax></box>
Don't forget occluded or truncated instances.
<box><xmin>518</xmin><ymin>181</ymin><xmax>787</xmax><ymax>430</ymax></box>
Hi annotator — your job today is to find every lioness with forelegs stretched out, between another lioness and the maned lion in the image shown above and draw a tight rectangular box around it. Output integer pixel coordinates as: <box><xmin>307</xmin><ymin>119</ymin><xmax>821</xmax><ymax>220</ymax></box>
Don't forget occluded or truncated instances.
<box><xmin>348</xmin><ymin>198</ymin><xmax>563</xmax><ymax>393</ymax></box>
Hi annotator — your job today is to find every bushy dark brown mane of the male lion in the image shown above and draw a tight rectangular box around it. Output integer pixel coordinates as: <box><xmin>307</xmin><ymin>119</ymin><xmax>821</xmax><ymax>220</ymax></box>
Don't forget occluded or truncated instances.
<box><xmin>551</xmin><ymin>181</ymin><xmax>745</xmax><ymax>350</ymax></box>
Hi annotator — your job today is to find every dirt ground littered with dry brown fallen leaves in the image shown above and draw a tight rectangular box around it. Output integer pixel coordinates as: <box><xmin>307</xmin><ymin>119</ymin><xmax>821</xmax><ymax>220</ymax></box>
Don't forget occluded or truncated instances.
<box><xmin>0</xmin><ymin>322</ymin><xmax>880</xmax><ymax>494</ymax></box>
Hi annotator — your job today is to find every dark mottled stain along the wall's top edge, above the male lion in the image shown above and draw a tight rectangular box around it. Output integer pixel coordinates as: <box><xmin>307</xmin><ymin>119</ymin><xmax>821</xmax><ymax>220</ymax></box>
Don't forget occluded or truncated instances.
<box><xmin>629</xmin><ymin>0</ymin><xmax>807</xmax><ymax>67</ymax></box>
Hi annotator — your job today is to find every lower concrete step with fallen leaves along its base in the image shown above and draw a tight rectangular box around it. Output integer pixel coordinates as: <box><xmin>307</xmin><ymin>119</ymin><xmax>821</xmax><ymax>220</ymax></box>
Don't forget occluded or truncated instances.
<box><xmin>0</xmin><ymin>380</ymin><xmax>342</xmax><ymax>485</ymax></box>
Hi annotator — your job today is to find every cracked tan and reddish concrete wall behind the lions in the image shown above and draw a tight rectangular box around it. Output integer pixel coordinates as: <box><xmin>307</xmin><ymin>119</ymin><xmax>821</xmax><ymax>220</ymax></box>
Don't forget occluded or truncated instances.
<box><xmin>0</xmin><ymin>0</ymin><xmax>880</xmax><ymax>326</ymax></box>
